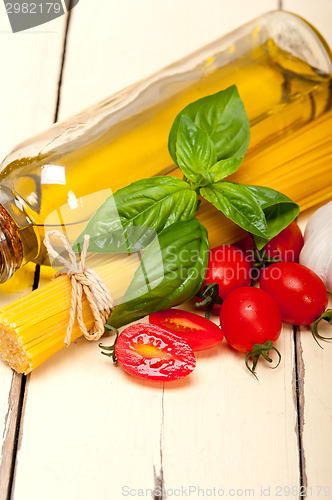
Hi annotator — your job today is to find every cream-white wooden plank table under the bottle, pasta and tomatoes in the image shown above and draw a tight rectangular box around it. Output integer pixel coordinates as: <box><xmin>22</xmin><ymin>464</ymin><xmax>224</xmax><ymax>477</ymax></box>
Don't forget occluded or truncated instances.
<box><xmin>0</xmin><ymin>0</ymin><xmax>332</xmax><ymax>500</ymax></box>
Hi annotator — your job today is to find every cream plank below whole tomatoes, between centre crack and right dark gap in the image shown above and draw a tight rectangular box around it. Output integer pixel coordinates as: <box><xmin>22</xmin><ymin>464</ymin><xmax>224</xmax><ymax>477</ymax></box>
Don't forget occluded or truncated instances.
<box><xmin>163</xmin><ymin>314</ymin><xmax>300</xmax><ymax>498</ymax></box>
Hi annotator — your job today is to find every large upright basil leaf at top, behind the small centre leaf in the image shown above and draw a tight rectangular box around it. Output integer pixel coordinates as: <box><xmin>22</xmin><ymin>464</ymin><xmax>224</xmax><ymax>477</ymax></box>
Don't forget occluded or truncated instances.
<box><xmin>168</xmin><ymin>85</ymin><xmax>250</xmax><ymax>164</ymax></box>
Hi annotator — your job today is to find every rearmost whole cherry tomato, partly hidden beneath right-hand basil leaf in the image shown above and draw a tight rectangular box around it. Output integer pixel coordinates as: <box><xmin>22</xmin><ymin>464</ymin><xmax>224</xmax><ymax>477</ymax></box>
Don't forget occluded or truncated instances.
<box><xmin>240</xmin><ymin>221</ymin><xmax>304</xmax><ymax>262</ymax></box>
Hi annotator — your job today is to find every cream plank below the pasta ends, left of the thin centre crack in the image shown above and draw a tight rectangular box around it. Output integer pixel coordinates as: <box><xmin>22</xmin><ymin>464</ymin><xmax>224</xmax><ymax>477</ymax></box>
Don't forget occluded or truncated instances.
<box><xmin>14</xmin><ymin>332</ymin><xmax>162</xmax><ymax>500</ymax></box>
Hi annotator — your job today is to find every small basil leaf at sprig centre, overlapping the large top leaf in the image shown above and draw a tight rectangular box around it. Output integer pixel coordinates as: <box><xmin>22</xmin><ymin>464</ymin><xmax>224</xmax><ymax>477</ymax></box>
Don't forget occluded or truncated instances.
<box><xmin>176</xmin><ymin>115</ymin><xmax>217</xmax><ymax>184</ymax></box>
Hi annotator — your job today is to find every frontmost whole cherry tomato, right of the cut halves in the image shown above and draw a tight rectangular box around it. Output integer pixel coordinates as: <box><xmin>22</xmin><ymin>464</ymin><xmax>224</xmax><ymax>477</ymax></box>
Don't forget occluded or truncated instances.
<box><xmin>220</xmin><ymin>287</ymin><xmax>282</xmax><ymax>353</ymax></box>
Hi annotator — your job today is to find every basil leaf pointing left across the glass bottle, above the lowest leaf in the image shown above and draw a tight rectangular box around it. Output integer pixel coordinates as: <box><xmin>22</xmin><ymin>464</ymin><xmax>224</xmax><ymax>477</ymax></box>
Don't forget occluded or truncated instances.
<box><xmin>73</xmin><ymin>176</ymin><xmax>197</xmax><ymax>253</ymax></box>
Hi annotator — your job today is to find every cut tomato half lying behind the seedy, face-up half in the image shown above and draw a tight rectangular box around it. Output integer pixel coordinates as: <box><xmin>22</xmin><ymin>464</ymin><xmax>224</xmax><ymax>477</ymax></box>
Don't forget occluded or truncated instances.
<box><xmin>149</xmin><ymin>309</ymin><xmax>224</xmax><ymax>351</ymax></box>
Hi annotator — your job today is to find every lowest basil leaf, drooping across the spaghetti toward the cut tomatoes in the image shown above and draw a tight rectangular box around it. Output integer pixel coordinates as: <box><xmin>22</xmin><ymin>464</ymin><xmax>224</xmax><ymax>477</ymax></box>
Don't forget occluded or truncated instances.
<box><xmin>107</xmin><ymin>218</ymin><xmax>209</xmax><ymax>328</ymax></box>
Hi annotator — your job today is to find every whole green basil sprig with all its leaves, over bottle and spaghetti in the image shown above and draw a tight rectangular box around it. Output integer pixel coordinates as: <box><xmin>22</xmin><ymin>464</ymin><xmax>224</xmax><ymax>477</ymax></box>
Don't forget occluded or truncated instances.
<box><xmin>73</xmin><ymin>85</ymin><xmax>299</xmax><ymax>328</ymax></box>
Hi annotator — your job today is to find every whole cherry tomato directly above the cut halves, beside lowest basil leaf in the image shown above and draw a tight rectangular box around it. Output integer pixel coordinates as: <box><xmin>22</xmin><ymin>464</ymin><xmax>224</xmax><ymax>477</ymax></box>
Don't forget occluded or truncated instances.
<box><xmin>204</xmin><ymin>245</ymin><xmax>251</xmax><ymax>299</ymax></box>
